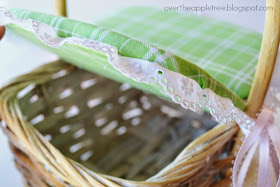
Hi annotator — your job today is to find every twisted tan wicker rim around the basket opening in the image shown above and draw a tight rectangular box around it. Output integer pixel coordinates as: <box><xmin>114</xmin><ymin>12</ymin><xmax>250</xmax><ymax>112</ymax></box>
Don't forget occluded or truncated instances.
<box><xmin>0</xmin><ymin>61</ymin><xmax>237</xmax><ymax>186</ymax></box>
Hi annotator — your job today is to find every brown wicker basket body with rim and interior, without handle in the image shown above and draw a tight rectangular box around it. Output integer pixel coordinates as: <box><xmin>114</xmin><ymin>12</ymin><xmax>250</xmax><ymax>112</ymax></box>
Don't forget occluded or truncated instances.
<box><xmin>0</xmin><ymin>61</ymin><xmax>238</xmax><ymax>186</ymax></box>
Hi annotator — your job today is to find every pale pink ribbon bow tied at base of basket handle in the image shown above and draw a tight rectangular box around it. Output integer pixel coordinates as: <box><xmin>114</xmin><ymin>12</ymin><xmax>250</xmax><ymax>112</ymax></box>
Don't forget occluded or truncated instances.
<box><xmin>232</xmin><ymin>108</ymin><xmax>280</xmax><ymax>187</ymax></box>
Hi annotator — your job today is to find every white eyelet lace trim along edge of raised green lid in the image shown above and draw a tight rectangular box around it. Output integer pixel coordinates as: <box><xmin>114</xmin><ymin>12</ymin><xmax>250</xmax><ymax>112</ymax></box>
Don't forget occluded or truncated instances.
<box><xmin>0</xmin><ymin>8</ymin><xmax>254</xmax><ymax>134</ymax></box>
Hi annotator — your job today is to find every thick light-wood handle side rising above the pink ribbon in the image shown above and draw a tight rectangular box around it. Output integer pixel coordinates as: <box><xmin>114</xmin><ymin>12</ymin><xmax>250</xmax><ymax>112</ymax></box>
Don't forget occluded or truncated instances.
<box><xmin>246</xmin><ymin>0</ymin><xmax>280</xmax><ymax>117</ymax></box>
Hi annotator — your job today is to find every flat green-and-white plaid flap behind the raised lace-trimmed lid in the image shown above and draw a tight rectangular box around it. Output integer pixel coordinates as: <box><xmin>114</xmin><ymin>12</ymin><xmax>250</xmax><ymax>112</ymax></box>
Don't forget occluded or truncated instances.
<box><xmin>97</xmin><ymin>7</ymin><xmax>262</xmax><ymax>98</ymax></box>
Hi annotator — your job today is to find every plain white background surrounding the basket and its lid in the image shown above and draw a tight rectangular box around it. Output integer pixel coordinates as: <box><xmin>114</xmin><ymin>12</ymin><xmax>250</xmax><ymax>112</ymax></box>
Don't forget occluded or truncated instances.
<box><xmin>0</xmin><ymin>0</ymin><xmax>265</xmax><ymax>187</ymax></box>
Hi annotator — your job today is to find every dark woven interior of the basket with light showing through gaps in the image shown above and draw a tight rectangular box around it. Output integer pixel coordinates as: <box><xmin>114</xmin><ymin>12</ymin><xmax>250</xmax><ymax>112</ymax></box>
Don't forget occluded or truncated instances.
<box><xmin>18</xmin><ymin>68</ymin><xmax>220</xmax><ymax>181</ymax></box>
